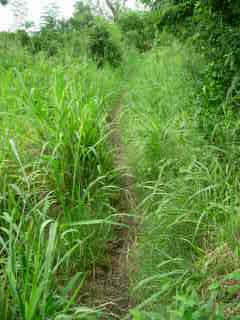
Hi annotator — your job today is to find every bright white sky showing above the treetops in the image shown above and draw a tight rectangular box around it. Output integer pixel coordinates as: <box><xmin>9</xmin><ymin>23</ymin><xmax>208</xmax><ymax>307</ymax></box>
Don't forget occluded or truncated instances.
<box><xmin>0</xmin><ymin>0</ymin><xmax>139</xmax><ymax>31</ymax></box>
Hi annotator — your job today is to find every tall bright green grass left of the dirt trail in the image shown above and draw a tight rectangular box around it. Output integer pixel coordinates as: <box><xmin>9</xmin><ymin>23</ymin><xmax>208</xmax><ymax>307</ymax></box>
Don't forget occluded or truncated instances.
<box><xmin>0</xmin><ymin>48</ymin><xmax>124</xmax><ymax>320</ymax></box>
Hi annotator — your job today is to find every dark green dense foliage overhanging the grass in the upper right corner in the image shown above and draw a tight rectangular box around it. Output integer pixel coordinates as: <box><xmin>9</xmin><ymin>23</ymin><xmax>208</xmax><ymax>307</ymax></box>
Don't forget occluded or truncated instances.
<box><xmin>142</xmin><ymin>0</ymin><xmax>240</xmax><ymax>108</ymax></box>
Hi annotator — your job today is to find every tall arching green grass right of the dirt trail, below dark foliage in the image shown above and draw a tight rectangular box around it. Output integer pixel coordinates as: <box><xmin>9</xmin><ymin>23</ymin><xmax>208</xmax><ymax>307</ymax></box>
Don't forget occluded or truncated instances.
<box><xmin>124</xmin><ymin>39</ymin><xmax>239</xmax><ymax>319</ymax></box>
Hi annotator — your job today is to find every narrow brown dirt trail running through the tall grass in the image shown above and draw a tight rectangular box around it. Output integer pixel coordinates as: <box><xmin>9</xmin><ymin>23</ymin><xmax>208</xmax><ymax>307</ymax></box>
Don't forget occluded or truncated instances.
<box><xmin>84</xmin><ymin>98</ymin><xmax>136</xmax><ymax>320</ymax></box>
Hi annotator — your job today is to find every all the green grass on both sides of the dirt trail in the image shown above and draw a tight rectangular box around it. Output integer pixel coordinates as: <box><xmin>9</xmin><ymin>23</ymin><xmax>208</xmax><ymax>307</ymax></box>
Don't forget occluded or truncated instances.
<box><xmin>0</xmin><ymin>28</ymin><xmax>240</xmax><ymax>320</ymax></box>
